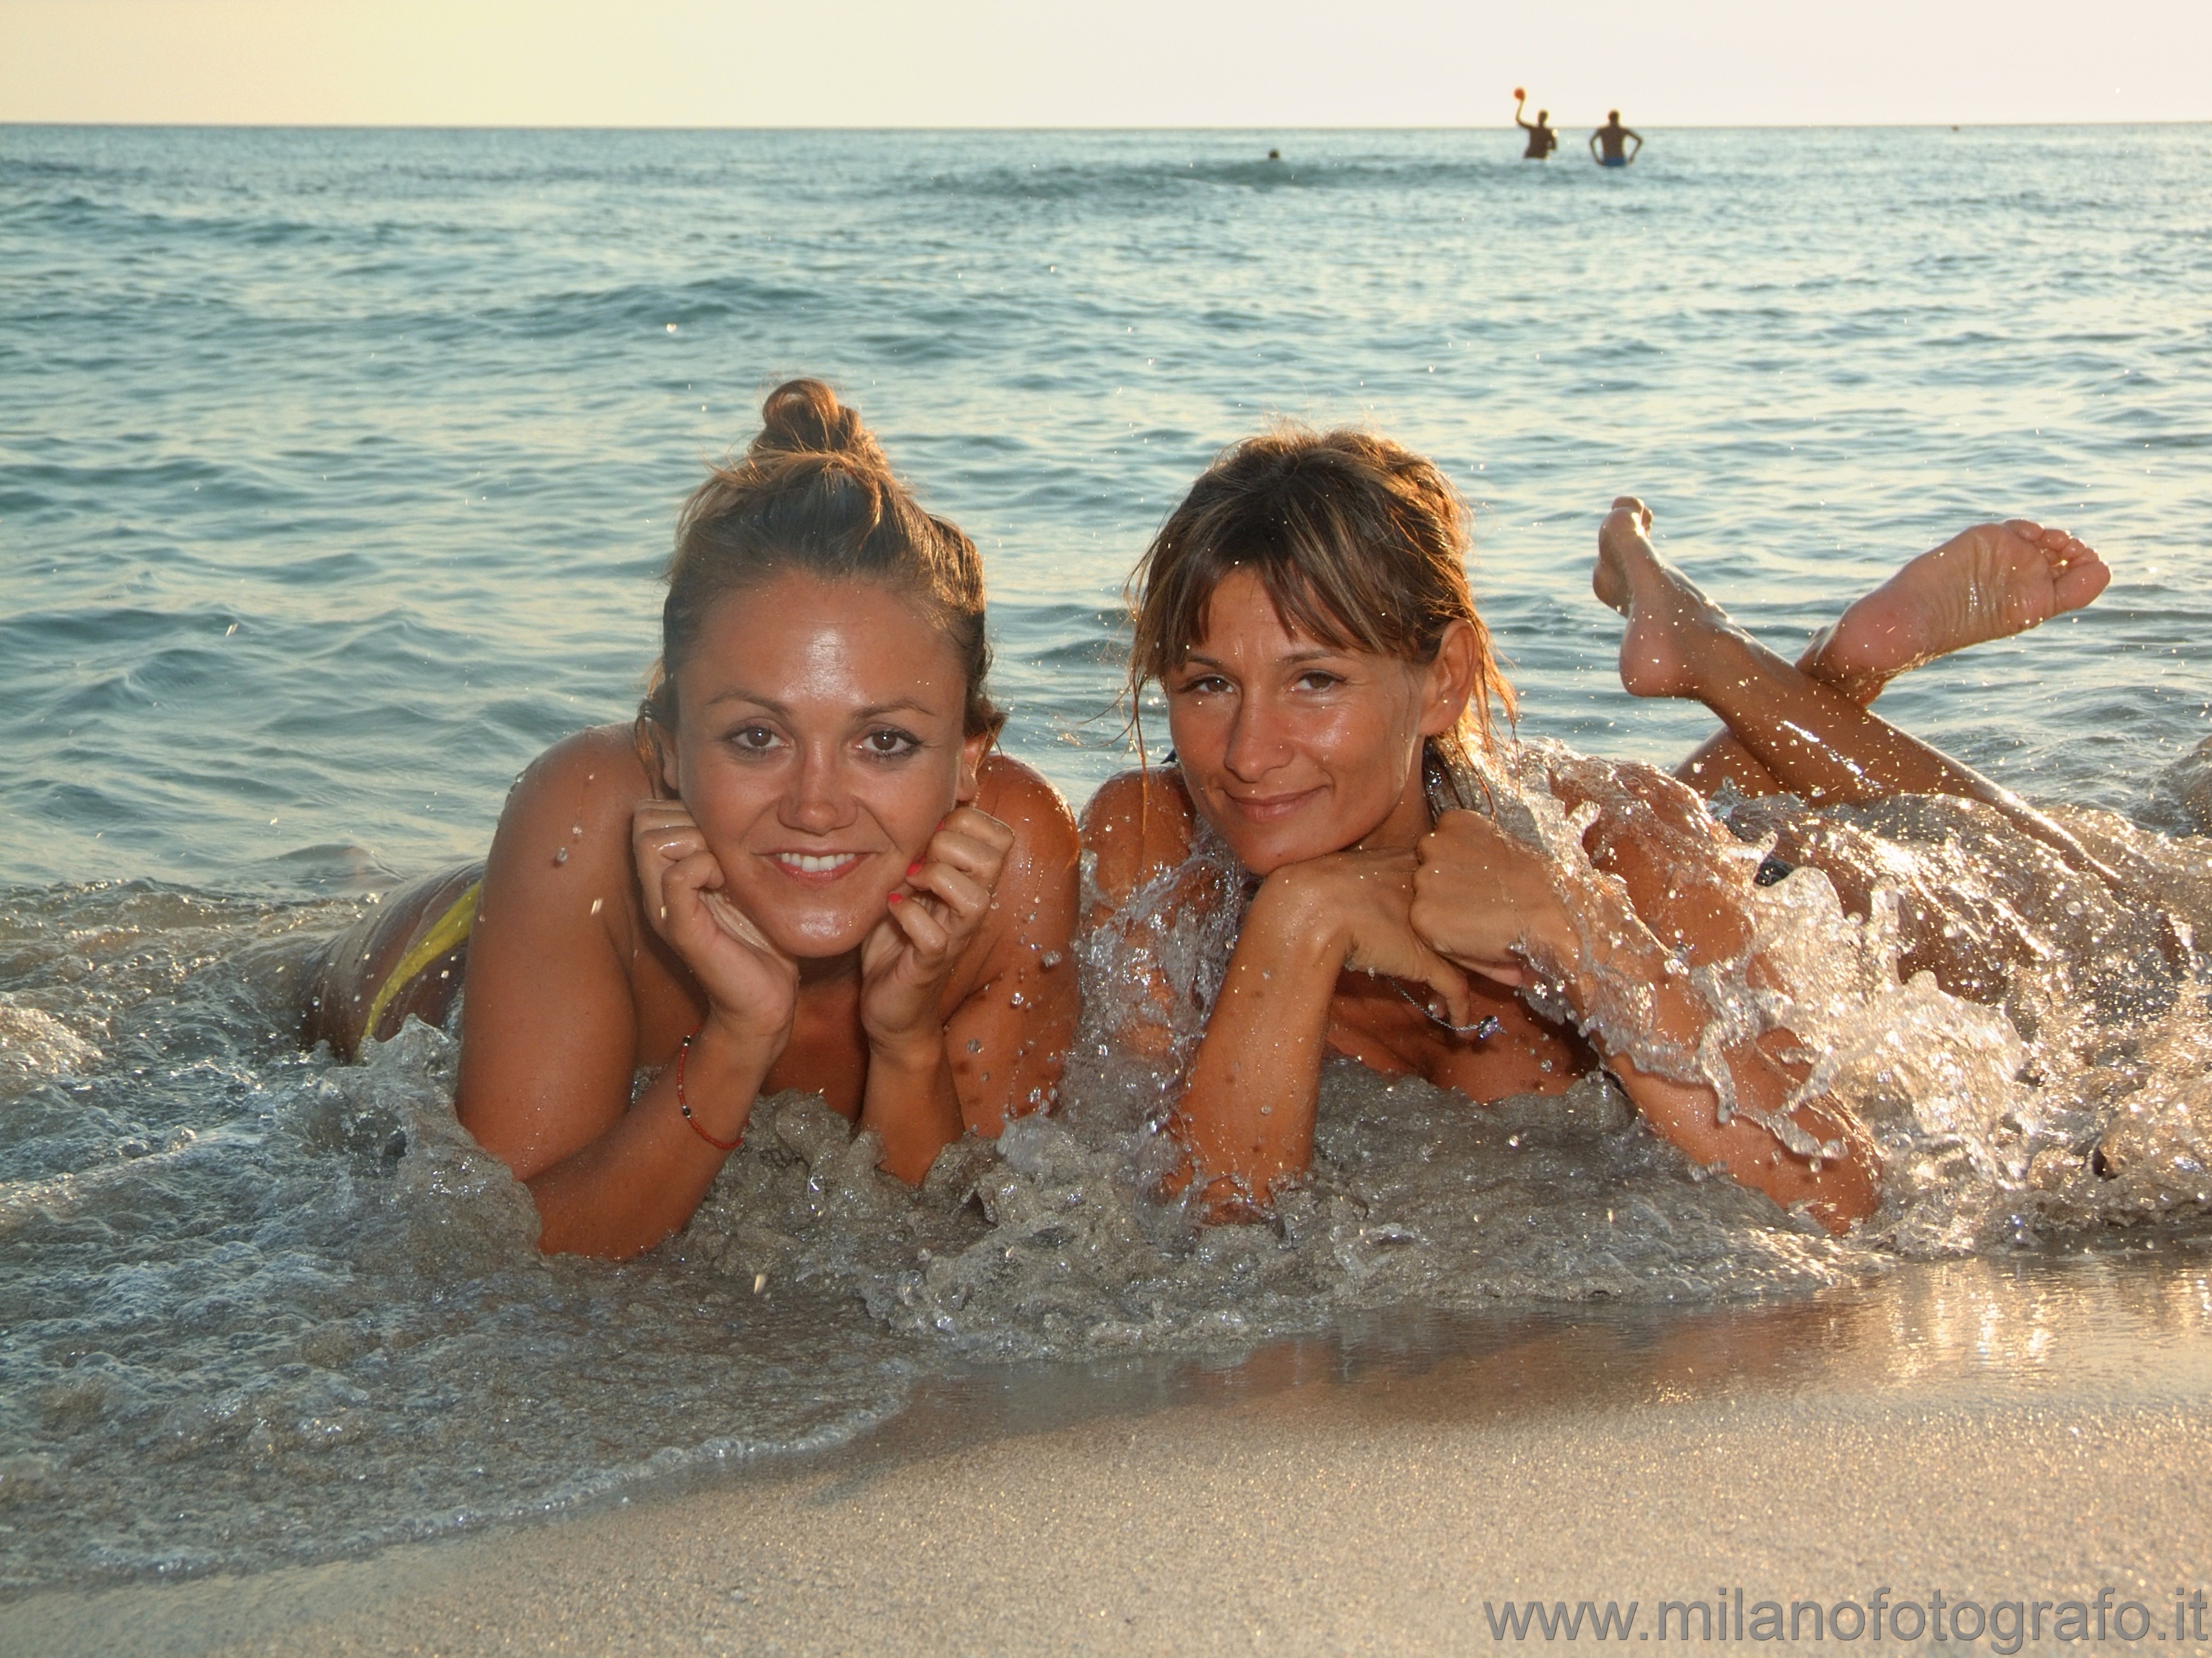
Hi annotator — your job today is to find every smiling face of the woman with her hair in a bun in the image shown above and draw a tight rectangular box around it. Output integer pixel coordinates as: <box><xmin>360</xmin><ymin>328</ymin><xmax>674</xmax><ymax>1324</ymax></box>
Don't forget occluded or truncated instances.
<box><xmin>668</xmin><ymin>572</ymin><xmax>987</xmax><ymax>957</ymax></box>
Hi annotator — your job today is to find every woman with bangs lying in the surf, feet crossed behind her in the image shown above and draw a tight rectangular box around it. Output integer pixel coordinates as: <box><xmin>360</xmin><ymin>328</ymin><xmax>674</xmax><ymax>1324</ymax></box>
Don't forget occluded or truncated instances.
<box><xmin>1084</xmin><ymin>431</ymin><xmax>2117</xmax><ymax>1231</ymax></box>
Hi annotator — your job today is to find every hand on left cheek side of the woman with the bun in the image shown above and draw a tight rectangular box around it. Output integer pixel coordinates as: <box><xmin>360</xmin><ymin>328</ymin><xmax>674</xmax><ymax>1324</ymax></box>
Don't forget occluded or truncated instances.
<box><xmin>631</xmin><ymin>800</ymin><xmax>799</xmax><ymax>1070</ymax></box>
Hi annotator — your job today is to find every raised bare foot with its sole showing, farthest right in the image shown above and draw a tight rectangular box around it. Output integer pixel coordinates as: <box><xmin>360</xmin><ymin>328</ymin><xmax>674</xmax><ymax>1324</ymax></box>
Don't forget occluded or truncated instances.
<box><xmin>1798</xmin><ymin>517</ymin><xmax>2112</xmax><ymax>703</ymax></box>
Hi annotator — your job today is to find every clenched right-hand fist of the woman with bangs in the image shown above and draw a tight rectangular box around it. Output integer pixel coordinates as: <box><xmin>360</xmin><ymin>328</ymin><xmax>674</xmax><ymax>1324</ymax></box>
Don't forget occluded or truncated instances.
<box><xmin>1411</xmin><ymin>811</ymin><xmax>1575</xmax><ymax>986</ymax></box>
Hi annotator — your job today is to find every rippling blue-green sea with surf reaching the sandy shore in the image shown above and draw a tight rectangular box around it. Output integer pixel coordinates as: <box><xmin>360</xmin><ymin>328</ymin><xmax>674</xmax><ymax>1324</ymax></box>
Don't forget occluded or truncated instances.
<box><xmin>0</xmin><ymin>126</ymin><xmax>2212</xmax><ymax>1596</ymax></box>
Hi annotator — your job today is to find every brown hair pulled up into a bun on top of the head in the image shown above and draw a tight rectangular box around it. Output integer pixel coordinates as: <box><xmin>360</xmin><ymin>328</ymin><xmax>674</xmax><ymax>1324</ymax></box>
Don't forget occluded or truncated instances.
<box><xmin>637</xmin><ymin>380</ymin><xmax>1004</xmax><ymax>776</ymax></box>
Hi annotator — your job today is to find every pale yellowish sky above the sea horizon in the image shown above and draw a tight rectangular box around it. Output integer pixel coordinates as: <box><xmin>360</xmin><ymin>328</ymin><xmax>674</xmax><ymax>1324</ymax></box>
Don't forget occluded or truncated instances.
<box><xmin>0</xmin><ymin>0</ymin><xmax>2212</xmax><ymax>128</ymax></box>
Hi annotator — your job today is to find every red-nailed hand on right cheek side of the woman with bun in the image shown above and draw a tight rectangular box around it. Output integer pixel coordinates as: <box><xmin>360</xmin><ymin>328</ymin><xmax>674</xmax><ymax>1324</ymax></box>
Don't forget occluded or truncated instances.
<box><xmin>860</xmin><ymin>807</ymin><xmax>1013</xmax><ymax>1057</ymax></box>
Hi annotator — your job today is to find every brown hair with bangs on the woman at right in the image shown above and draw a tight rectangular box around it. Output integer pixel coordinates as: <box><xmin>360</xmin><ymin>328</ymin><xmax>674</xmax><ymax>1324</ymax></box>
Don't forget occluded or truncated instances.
<box><xmin>1128</xmin><ymin>427</ymin><xmax>1515</xmax><ymax>805</ymax></box>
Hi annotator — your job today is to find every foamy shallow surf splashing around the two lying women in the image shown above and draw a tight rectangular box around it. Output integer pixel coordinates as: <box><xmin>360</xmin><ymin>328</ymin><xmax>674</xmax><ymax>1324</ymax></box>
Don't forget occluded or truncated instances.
<box><xmin>0</xmin><ymin>750</ymin><xmax>2212</xmax><ymax>1590</ymax></box>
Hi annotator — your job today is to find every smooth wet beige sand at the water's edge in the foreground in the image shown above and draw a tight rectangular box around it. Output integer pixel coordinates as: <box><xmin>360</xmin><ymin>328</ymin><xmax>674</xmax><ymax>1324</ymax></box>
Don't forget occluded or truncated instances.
<box><xmin>17</xmin><ymin>1251</ymin><xmax>2212</xmax><ymax>1654</ymax></box>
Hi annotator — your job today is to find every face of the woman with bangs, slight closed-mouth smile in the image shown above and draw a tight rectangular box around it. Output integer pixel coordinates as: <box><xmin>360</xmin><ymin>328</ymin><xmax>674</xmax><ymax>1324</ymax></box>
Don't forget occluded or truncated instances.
<box><xmin>1163</xmin><ymin>570</ymin><xmax>1467</xmax><ymax>875</ymax></box>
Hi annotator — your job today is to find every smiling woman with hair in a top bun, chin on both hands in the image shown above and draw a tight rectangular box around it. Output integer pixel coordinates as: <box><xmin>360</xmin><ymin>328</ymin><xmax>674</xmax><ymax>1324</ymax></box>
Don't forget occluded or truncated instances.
<box><xmin>307</xmin><ymin>380</ymin><xmax>1077</xmax><ymax>1258</ymax></box>
